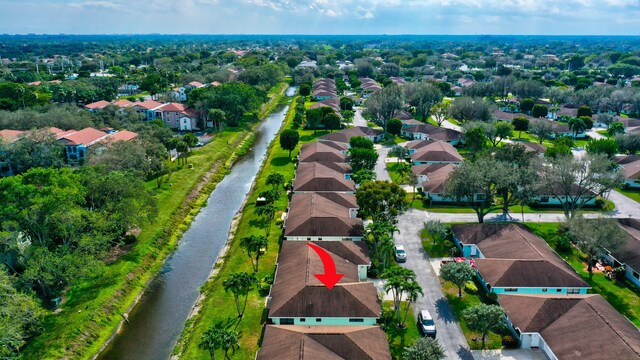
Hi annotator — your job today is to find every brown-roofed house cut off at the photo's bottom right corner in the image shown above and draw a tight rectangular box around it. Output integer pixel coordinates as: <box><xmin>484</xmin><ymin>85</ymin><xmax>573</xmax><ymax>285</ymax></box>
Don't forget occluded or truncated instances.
<box><xmin>498</xmin><ymin>294</ymin><xmax>640</xmax><ymax>360</ymax></box>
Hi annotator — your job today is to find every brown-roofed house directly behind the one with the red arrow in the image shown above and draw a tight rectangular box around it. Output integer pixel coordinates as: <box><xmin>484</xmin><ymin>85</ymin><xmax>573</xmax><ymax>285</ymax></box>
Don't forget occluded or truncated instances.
<box><xmin>284</xmin><ymin>192</ymin><xmax>364</xmax><ymax>241</ymax></box>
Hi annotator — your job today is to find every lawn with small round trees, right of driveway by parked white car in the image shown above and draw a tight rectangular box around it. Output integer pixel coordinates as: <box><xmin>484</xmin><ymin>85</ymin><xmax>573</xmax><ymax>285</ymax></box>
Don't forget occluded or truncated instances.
<box><xmin>440</xmin><ymin>279</ymin><xmax>510</xmax><ymax>350</ymax></box>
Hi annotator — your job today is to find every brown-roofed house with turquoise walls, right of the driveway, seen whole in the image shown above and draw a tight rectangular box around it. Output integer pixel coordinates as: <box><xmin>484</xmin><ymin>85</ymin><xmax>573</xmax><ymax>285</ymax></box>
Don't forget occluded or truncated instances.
<box><xmin>451</xmin><ymin>224</ymin><xmax>591</xmax><ymax>295</ymax></box>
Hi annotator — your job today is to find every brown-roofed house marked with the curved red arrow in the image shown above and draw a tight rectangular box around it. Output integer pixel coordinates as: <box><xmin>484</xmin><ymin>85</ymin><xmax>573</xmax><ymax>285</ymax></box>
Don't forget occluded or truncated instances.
<box><xmin>267</xmin><ymin>241</ymin><xmax>382</xmax><ymax>326</ymax></box>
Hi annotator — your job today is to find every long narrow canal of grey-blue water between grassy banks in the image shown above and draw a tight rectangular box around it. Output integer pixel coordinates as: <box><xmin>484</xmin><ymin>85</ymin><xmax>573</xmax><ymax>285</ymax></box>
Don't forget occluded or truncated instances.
<box><xmin>98</xmin><ymin>87</ymin><xmax>296</xmax><ymax>360</ymax></box>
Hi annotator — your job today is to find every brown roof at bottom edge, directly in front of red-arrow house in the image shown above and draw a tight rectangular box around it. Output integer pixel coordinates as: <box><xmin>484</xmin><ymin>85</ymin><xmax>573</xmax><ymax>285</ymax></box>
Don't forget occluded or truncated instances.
<box><xmin>256</xmin><ymin>325</ymin><xmax>391</xmax><ymax>360</ymax></box>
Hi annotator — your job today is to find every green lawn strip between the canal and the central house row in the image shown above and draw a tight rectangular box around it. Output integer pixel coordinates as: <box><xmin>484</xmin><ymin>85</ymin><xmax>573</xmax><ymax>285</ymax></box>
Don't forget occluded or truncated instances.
<box><xmin>174</xmin><ymin>99</ymin><xmax>336</xmax><ymax>359</ymax></box>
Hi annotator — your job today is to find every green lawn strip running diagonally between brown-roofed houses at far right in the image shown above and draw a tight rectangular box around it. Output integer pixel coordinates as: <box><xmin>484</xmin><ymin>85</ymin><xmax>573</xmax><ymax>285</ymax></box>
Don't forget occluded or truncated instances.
<box><xmin>526</xmin><ymin>223</ymin><xmax>640</xmax><ymax>326</ymax></box>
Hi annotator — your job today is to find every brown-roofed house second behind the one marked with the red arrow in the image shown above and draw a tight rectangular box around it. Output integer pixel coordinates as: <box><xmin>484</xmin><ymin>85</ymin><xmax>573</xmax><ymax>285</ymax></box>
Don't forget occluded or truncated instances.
<box><xmin>293</xmin><ymin>162</ymin><xmax>356</xmax><ymax>194</ymax></box>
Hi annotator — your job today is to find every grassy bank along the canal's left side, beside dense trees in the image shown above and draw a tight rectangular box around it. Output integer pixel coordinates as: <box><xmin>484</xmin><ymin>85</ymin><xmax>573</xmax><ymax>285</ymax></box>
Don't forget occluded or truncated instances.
<box><xmin>22</xmin><ymin>83</ymin><xmax>287</xmax><ymax>359</ymax></box>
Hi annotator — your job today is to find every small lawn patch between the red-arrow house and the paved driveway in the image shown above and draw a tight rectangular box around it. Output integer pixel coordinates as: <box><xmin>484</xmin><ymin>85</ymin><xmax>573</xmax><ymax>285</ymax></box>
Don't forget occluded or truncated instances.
<box><xmin>382</xmin><ymin>301</ymin><xmax>422</xmax><ymax>359</ymax></box>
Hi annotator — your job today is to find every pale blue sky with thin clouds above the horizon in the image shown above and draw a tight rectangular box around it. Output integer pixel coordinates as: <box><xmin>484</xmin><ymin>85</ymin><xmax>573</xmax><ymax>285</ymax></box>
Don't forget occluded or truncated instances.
<box><xmin>0</xmin><ymin>0</ymin><xmax>640</xmax><ymax>35</ymax></box>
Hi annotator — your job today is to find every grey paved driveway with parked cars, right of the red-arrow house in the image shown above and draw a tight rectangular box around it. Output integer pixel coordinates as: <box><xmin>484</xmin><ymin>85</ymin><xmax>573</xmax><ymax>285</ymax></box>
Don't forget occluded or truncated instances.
<box><xmin>395</xmin><ymin>209</ymin><xmax>473</xmax><ymax>360</ymax></box>
